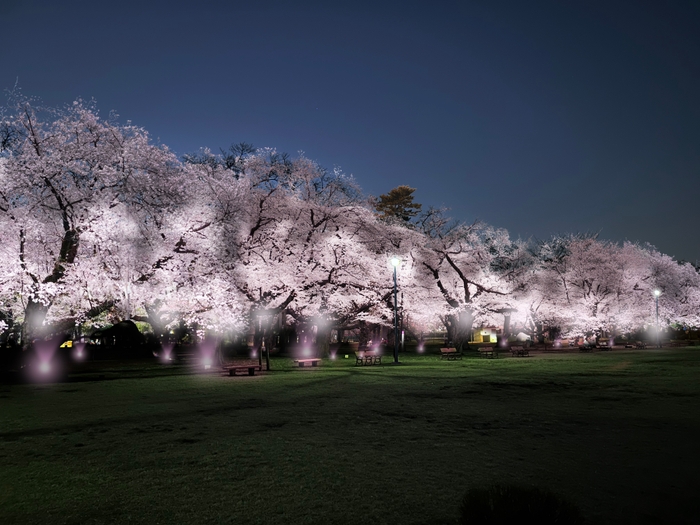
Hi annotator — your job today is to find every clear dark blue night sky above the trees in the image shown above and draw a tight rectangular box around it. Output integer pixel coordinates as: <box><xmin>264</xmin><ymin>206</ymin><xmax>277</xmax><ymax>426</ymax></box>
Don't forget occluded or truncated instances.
<box><xmin>5</xmin><ymin>0</ymin><xmax>700</xmax><ymax>261</ymax></box>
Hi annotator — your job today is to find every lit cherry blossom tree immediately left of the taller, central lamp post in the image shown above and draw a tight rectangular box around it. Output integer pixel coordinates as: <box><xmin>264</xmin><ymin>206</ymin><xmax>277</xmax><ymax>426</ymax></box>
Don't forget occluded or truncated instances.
<box><xmin>208</xmin><ymin>150</ymin><xmax>402</xmax><ymax>351</ymax></box>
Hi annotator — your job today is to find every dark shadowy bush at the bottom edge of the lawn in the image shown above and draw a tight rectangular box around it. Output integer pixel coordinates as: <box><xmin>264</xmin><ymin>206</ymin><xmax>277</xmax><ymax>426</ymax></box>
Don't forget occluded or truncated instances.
<box><xmin>459</xmin><ymin>485</ymin><xmax>584</xmax><ymax>525</ymax></box>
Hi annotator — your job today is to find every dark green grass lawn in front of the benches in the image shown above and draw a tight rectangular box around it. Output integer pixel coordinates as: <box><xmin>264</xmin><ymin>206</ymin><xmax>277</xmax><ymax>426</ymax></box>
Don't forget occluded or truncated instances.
<box><xmin>0</xmin><ymin>349</ymin><xmax>700</xmax><ymax>525</ymax></box>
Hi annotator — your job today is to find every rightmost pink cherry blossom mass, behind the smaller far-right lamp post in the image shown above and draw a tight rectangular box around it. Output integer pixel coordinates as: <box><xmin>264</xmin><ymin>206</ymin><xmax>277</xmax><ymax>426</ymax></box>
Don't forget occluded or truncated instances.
<box><xmin>521</xmin><ymin>235</ymin><xmax>698</xmax><ymax>342</ymax></box>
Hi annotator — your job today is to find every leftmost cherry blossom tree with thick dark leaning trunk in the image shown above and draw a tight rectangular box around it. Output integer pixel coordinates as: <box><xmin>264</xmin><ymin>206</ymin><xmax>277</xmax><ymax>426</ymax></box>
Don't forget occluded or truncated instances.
<box><xmin>0</xmin><ymin>99</ymin><xmax>181</xmax><ymax>344</ymax></box>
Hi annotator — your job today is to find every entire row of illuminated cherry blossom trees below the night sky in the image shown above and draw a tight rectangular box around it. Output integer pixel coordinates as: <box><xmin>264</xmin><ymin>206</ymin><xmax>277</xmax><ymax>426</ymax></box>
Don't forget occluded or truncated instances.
<box><xmin>0</xmin><ymin>95</ymin><xmax>700</xmax><ymax>353</ymax></box>
